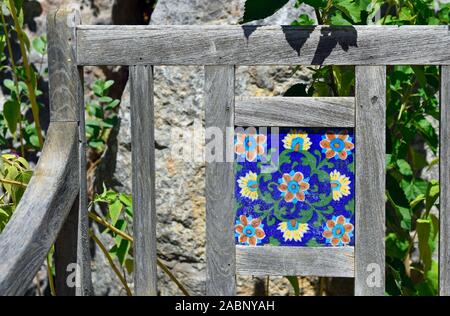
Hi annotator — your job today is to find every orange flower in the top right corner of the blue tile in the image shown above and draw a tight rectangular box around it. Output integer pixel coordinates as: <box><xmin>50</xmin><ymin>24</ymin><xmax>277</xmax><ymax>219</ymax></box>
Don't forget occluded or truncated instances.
<box><xmin>320</xmin><ymin>130</ymin><xmax>355</xmax><ymax>160</ymax></box>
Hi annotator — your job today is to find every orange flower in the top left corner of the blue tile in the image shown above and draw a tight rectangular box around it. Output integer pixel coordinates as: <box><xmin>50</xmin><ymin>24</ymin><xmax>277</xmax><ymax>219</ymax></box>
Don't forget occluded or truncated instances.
<box><xmin>234</xmin><ymin>128</ymin><xmax>267</xmax><ymax>162</ymax></box>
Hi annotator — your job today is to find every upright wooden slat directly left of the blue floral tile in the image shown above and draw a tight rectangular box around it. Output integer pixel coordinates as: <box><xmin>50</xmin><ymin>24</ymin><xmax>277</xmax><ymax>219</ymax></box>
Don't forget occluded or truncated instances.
<box><xmin>205</xmin><ymin>66</ymin><xmax>236</xmax><ymax>295</ymax></box>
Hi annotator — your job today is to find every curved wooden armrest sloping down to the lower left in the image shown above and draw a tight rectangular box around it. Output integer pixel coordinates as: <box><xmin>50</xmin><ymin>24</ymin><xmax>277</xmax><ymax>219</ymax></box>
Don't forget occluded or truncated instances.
<box><xmin>0</xmin><ymin>122</ymin><xmax>78</xmax><ymax>295</ymax></box>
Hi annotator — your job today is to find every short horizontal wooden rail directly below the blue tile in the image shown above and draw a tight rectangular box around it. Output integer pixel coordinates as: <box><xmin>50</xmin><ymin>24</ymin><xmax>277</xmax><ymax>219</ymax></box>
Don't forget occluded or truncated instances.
<box><xmin>236</xmin><ymin>246</ymin><xmax>355</xmax><ymax>278</ymax></box>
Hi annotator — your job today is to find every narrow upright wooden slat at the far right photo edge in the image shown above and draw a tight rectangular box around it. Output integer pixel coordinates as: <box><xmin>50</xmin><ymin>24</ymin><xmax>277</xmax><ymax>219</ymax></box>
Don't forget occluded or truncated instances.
<box><xmin>439</xmin><ymin>66</ymin><xmax>450</xmax><ymax>296</ymax></box>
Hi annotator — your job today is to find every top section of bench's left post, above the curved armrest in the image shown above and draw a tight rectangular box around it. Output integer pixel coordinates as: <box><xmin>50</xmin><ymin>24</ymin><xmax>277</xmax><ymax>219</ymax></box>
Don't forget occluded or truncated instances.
<box><xmin>47</xmin><ymin>8</ymin><xmax>83</xmax><ymax>122</ymax></box>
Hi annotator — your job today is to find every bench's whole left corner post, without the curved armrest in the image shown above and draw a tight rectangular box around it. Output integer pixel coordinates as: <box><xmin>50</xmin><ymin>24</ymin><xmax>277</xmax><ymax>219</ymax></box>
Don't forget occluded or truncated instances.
<box><xmin>47</xmin><ymin>9</ymin><xmax>92</xmax><ymax>295</ymax></box>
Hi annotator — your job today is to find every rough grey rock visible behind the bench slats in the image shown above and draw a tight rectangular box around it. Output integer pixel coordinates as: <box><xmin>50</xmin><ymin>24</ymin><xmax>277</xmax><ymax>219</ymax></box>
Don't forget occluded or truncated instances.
<box><xmin>112</xmin><ymin>0</ymin><xmax>309</xmax><ymax>295</ymax></box>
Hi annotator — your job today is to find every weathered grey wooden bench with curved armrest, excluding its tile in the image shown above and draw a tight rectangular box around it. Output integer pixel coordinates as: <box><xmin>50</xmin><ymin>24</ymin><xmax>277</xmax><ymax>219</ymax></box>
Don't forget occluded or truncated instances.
<box><xmin>0</xmin><ymin>9</ymin><xmax>450</xmax><ymax>295</ymax></box>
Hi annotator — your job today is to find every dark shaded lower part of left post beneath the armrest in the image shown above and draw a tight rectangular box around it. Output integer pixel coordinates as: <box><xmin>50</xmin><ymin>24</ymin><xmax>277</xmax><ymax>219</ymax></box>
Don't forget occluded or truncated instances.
<box><xmin>54</xmin><ymin>197</ymin><xmax>79</xmax><ymax>296</ymax></box>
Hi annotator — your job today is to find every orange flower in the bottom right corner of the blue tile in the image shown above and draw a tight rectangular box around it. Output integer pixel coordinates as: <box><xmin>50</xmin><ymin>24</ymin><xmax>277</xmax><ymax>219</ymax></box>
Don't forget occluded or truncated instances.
<box><xmin>322</xmin><ymin>215</ymin><xmax>353</xmax><ymax>246</ymax></box>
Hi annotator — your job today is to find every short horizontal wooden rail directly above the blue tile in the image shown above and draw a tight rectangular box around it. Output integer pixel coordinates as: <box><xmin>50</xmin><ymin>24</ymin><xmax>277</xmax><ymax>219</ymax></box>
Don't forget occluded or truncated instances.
<box><xmin>235</xmin><ymin>97</ymin><xmax>355</xmax><ymax>127</ymax></box>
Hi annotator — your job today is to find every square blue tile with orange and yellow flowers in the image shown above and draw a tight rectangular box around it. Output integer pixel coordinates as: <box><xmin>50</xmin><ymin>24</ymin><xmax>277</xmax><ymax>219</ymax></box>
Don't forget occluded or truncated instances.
<box><xmin>234</xmin><ymin>128</ymin><xmax>355</xmax><ymax>247</ymax></box>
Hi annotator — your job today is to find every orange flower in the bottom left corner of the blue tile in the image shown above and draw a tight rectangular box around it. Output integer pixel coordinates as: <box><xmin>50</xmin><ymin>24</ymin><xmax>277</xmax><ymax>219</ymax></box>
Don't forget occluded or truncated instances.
<box><xmin>235</xmin><ymin>215</ymin><xmax>266</xmax><ymax>246</ymax></box>
